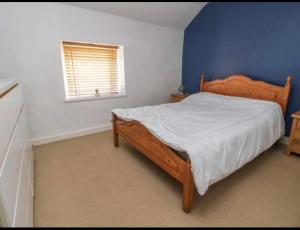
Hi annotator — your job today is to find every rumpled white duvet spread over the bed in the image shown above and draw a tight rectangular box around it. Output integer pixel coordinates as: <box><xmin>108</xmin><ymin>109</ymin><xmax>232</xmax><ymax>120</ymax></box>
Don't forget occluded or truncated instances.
<box><xmin>113</xmin><ymin>92</ymin><xmax>284</xmax><ymax>195</ymax></box>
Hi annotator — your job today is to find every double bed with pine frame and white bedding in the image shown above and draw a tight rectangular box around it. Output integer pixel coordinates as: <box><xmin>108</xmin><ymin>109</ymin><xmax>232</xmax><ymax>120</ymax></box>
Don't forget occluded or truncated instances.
<box><xmin>112</xmin><ymin>75</ymin><xmax>291</xmax><ymax>213</ymax></box>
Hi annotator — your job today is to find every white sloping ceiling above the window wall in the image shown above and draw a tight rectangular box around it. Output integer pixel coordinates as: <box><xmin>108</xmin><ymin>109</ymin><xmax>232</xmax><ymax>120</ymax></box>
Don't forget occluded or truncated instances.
<box><xmin>63</xmin><ymin>2</ymin><xmax>207</xmax><ymax>30</ymax></box>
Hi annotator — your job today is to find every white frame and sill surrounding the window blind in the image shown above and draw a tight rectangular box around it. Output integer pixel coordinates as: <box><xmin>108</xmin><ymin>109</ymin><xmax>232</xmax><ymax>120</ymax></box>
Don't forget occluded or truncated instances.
<box><xmin>59</xmin><ymin>40</ymin><xmax>127</xmax><ymax>103</ymax></box>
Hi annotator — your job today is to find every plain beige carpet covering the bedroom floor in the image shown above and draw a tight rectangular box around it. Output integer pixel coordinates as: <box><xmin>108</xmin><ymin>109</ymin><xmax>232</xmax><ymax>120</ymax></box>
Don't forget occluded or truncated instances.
<box><xmin>34</xmin><ymin>131</ymin><xmax>300</xmax><ymax>226</ymax></box>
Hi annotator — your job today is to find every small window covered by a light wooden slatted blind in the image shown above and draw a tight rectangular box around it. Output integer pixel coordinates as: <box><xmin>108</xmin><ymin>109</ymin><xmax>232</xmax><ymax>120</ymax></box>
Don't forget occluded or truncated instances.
<box><xmin>61</xmin><ymin>41</ymin><xmax>125</xmax><ymax>101</ymax></box>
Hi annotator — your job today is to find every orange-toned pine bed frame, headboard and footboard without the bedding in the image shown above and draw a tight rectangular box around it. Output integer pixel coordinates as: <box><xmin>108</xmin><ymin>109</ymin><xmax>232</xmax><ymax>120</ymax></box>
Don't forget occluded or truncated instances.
<box><xmin>112</xmin><ymin>74</ymin><xmax>291</xmax><ymax>213</ymax></box>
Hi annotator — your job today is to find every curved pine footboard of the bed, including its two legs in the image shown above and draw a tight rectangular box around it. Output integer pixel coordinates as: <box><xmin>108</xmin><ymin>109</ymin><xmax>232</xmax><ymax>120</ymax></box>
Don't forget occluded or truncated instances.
<box><xmin>112</xmin><ymin>113</ymin><xmax>195</xmax><ymax>213</ymax></box>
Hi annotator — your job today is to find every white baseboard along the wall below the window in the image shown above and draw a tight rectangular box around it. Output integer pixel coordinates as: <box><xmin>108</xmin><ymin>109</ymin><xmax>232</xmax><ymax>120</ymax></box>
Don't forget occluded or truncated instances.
<box><xmin>31</xmin><ymin>124</ymin><xmax>112</xmax><ymax>146</ymax></box>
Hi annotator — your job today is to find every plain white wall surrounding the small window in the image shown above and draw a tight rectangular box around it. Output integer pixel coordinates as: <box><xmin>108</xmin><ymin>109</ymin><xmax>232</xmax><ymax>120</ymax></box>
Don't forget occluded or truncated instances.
<box><xmin>0</xmin><ymin>3</ymin><xmax>183</xmax><ymax>144</ymax></box>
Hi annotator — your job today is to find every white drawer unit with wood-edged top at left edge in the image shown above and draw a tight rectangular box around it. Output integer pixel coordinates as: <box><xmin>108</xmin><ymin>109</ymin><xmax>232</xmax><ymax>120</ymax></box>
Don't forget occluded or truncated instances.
<box><xmin>0</xmin><ymin>80</ymin><xmax>34</xmax><ymax>227</ymax></box>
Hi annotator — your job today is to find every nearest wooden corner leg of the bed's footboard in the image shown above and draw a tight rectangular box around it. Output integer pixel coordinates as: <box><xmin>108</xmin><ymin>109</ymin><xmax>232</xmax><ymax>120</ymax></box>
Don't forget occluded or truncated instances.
<box><xmin>183</xmin><ymin>161</ymin><xmax>195</xmax><ymax>213</ymax></box>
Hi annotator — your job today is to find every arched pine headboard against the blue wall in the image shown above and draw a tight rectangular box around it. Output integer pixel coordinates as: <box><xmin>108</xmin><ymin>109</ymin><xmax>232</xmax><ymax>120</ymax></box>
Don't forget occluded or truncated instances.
<box><xmin>200</xmin><ymin>74</ymin><xmax>292</xmax><ymax>113</ymax></box>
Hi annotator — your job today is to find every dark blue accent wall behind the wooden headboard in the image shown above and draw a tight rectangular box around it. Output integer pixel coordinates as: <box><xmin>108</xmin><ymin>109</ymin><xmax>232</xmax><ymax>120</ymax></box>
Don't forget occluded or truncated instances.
<box><xmin>182</xmin><ymin>2</ymin><xmax>300</xmax><ymax>135</ymax></box>
